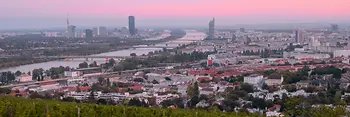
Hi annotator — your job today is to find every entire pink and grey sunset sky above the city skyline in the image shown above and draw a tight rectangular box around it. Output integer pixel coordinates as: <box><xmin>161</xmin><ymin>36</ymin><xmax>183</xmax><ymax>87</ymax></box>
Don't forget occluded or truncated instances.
<box><xmin>0</xmin><ymin>0</ymin><xmax>350</xmax><ymax>28</ymax></box>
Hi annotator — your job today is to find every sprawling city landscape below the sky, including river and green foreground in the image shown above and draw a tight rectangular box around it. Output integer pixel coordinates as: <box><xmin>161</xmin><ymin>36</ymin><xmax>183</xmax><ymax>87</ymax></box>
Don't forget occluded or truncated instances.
<box><xmin>0</xmin><ymin>16</ymin><xmax>350</xmax><ymax>117</ymax></box>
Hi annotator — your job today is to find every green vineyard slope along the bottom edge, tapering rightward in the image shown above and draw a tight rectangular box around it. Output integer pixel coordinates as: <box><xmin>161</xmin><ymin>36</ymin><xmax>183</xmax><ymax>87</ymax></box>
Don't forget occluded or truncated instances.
<box><xmin>0</xmin><ymin>97</ymin><xmax>263</xmax><ymax>117</ymax></box>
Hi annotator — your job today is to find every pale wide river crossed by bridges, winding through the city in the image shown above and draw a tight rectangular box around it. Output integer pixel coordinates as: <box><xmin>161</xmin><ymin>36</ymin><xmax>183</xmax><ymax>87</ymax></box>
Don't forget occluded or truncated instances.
<box><xmin>0</xmin><ymin>30</ymin><xmax>206</xmax><ymax>72</ymax></box>
